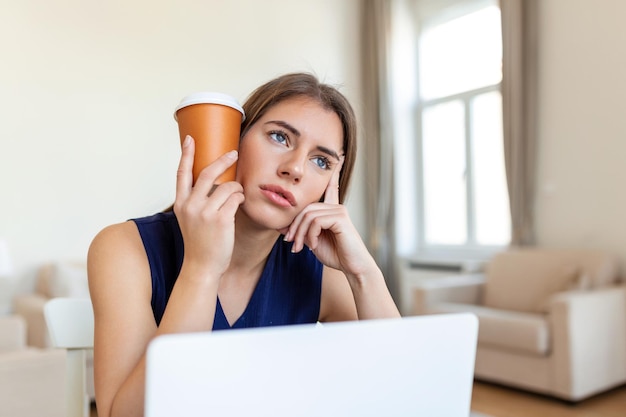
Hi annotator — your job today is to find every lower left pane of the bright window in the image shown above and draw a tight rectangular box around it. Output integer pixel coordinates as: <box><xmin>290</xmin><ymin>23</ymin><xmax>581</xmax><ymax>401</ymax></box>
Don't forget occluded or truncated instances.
<box><xmin>422</xmin><ymin>101</ymin><xmax>467</xmax><ymax>245</ymax></box>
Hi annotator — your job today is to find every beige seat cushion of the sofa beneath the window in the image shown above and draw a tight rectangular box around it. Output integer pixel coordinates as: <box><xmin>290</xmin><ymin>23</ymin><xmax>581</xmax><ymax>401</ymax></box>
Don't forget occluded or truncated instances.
<box><xmin>429</xmin><ymin>303</ymin><xmax>551</xmax><ymax>356</ymax></box>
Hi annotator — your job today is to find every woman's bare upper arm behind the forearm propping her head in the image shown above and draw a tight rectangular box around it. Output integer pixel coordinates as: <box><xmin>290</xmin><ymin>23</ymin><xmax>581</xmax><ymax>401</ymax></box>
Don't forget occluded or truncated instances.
<box><xmin>319</xmin><ymin>266</ymin><xmax>358</xmax><ymax>322</ymax></box>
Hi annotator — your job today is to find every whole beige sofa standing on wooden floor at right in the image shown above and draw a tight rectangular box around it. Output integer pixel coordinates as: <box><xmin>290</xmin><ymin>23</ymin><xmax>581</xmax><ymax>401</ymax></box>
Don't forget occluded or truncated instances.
<box><xmin>414</xmin><ymin>248</ymin><xmax>626</xmax><ymax>401</ymax></box>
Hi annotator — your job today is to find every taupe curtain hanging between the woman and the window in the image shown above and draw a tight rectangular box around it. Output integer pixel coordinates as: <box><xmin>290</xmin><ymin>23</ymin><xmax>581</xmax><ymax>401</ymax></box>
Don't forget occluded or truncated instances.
<box><xmin>361</xmin><ymin>0</ymin><xmax>400</xmax><ymax>302</ymax></box>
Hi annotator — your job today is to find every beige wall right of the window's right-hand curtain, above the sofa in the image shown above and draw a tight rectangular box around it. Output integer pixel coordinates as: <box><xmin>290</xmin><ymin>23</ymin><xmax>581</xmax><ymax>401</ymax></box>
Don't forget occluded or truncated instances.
<box><xmin>536</xmin><ymin>0</ymin><xmax>626</xmax><ymax>262</ymax></box>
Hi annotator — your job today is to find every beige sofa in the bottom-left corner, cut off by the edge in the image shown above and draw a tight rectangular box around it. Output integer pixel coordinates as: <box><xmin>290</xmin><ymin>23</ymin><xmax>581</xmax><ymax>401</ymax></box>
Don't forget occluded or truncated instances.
<box><xmin>0</xmin><ymin>315</ymin><xmax>65</xmax><ymax>417</ymax></box>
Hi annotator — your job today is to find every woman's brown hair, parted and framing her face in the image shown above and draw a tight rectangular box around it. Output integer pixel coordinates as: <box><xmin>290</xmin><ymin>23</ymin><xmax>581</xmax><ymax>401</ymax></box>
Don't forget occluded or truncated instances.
<box><xmin>241</xmin><ymin>73</ymin><xmax>356</xmax><ymax>203</ymax></box>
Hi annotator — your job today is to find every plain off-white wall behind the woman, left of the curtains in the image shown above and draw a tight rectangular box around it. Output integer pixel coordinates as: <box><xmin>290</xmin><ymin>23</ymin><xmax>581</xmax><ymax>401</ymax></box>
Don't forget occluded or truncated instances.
<box><xmin>0</xmin><ymin>0</ymin><xmax>363</xmax><ymax>297</ymax></box>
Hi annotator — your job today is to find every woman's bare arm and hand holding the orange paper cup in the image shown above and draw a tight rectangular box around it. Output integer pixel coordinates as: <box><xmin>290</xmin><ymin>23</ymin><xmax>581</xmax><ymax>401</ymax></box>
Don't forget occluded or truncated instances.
<box><xmin>88</xmin><ymin>139</ymin><xmax>243</xmax><ymax>417</ymax></box>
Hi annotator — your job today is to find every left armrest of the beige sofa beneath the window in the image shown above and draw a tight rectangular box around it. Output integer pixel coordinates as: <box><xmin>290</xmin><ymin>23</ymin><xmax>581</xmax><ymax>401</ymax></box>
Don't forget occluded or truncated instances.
<box><xmin>413</xmin><ymin>274</ymin><xmax>485</xmax><ymax>314</ymax></box>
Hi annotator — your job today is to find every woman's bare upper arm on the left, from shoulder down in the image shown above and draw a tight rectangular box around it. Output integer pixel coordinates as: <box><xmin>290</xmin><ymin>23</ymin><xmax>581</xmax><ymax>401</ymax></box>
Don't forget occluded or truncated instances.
<box><xmin>88</xmin><ymin>222</ymin><xmax>156</xmax><ymax>416</ymax></box>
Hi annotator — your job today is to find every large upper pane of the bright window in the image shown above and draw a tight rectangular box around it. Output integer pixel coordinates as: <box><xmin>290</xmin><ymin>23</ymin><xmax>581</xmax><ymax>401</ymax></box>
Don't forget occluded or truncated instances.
<box><xmin>419</xmin><ymin>6</ymin><xmax>502</xmax><ymax>99</ymax></box>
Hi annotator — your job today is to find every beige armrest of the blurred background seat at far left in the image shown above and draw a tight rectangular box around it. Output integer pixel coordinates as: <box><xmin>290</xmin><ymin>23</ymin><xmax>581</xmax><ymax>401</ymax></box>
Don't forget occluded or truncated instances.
<box><xmin>13</xmin><ymin>294</ymin><xmax>52</xmax><ymax>348</ymax></box>
